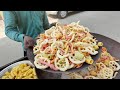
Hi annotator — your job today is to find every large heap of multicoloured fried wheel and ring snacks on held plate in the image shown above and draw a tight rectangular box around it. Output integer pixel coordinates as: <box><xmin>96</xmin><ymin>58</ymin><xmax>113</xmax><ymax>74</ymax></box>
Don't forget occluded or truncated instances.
<box><xmin>33</xmin><ymin>21</ymin><xmax>101</xmax><ymax>71</ymax></box>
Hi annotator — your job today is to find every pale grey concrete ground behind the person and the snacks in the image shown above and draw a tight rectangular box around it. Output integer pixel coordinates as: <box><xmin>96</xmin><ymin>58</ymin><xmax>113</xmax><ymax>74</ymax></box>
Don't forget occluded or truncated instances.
<box><xmin>0</xmin><ymin>11</ymin><xmax>120</xmax><ymax>66</ymax></box>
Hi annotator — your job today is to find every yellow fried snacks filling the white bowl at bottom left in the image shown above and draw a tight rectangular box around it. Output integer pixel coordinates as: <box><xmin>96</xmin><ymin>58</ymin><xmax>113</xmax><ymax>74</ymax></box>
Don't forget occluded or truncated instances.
<box><xmin>1</xmin><ymin>63</ymin><xmax>37</xmax><ymax>79</ymax></box>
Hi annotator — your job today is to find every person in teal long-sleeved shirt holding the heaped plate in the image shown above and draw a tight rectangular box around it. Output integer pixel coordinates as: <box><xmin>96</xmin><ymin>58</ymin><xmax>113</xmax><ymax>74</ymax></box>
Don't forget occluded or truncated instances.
<box><xmin>3</xmin><ymin>11</ymin><xmax>55</xmax><ymax>56</ymax></box>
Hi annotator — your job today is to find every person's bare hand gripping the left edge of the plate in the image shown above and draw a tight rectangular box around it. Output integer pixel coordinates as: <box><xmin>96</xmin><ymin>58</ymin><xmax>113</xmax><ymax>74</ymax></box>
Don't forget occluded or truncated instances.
<box><xmin>24</xmin><ymin>36</ymin><xmax>34</xmax><ymax>49</ymax></box>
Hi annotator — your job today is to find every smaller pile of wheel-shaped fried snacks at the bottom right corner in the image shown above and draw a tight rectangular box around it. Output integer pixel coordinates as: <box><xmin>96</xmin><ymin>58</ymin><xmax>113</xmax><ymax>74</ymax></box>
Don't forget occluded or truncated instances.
<box><xmin>84</xmin><ymin>47</ymin><xmax>120</xmax><ymax>79</ymax></box>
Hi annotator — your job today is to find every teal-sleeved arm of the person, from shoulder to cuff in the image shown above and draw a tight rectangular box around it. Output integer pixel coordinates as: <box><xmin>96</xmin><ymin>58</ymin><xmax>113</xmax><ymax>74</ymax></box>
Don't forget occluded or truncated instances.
<box><xmin>3</xmin><ymin>11</ymin><xmax>24</xmax><ymax>42</ymax></box>
